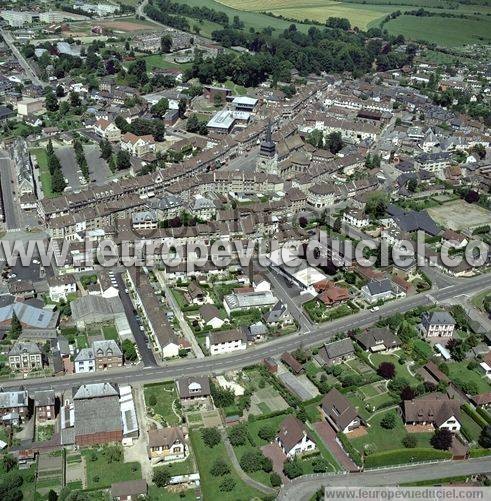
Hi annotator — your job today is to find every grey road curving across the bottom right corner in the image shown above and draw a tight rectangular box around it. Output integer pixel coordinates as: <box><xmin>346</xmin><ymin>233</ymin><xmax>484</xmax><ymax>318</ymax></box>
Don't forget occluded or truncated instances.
<box><xmin>278</xmin><ymin>456</ymin><xmax>491</xmax><ymax>501</ymax></box>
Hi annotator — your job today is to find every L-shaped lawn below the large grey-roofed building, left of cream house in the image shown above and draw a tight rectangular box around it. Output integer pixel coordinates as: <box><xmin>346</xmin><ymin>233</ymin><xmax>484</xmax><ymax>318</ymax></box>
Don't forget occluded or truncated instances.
<box><xmin>82</xmin><ymin>449</ymin><xmax>142</xmax><ymax>489</ymax></box>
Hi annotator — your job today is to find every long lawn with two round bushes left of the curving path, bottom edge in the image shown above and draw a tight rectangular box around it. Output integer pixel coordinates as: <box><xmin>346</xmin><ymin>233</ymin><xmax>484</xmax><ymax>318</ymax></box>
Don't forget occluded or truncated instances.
<box><xmin>189</xmin><ymin>430</ymin><xmax>259</xmax><ymax>501</ymax></box>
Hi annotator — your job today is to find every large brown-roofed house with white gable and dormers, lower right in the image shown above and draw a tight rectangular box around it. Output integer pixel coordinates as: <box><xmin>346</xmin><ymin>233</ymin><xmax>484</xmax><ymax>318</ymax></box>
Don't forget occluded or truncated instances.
<box><xmin>403</xmin><ymin>393</ymin><xmax>461</xmax><ymax>433</ymax></box>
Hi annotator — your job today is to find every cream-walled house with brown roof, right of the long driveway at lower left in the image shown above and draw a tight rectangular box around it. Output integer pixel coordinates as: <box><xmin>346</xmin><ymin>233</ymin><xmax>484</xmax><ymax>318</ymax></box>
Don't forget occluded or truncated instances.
<box><xmin>147</xmin><ymin>426</ymin><xmax>187</xmax><ymax>462</ymax></box>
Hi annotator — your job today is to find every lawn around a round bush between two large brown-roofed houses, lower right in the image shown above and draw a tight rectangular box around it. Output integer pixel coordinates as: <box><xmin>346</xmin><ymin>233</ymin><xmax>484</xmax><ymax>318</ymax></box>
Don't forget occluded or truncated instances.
<box><xmin>348</xmin><ymin>411</ymin><xmax>432</xmax><ymax>453</ymax></box>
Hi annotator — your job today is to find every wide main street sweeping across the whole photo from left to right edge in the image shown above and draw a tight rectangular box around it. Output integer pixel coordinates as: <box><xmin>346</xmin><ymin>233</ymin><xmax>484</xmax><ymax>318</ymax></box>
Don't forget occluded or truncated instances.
<box><xmin>2</xmin><ymin>274</ymin><xmax>491</xmax><ymax>391</ymax></box>
